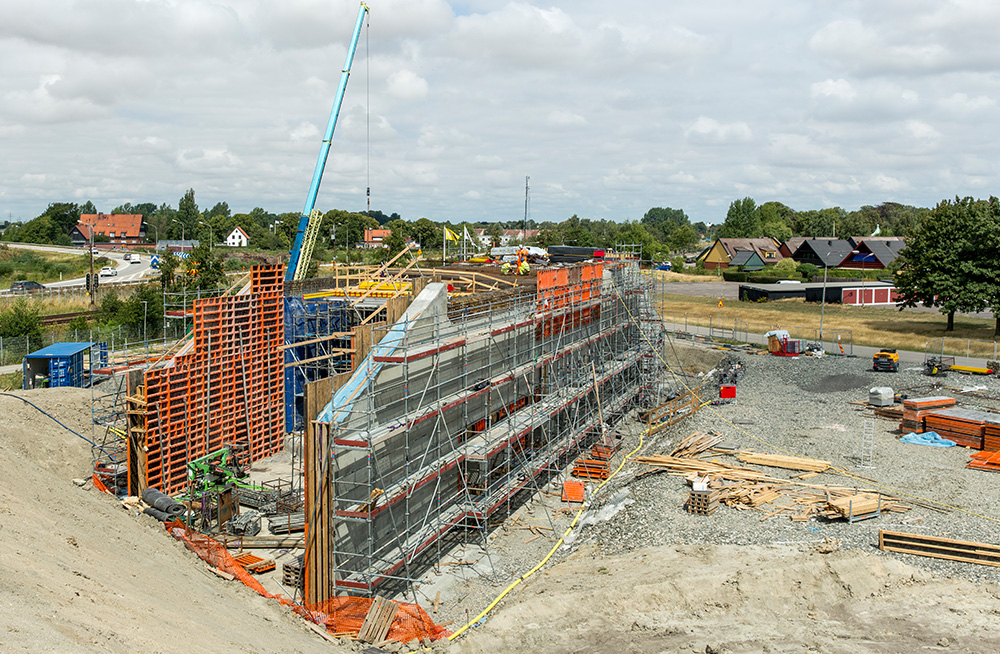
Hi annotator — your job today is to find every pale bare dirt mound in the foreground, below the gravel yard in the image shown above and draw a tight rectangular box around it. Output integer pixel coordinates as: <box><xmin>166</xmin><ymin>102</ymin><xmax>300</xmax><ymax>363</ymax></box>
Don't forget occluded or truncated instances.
<box><xmin>458</xmin><ymin>545</ymin><xmax>1000</xmax><ymax>654</ymax></box>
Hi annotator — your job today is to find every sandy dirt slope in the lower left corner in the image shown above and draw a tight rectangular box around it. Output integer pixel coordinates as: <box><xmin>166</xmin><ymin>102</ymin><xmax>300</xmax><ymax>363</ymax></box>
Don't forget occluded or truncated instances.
<box><xmin>0</xmin><ymin>389</ymin><xmax>336</xmax><ymax>652</ymax></box>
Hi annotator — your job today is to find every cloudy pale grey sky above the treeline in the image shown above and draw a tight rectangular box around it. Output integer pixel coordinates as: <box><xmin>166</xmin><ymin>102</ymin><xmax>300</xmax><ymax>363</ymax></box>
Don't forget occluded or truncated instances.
<box><xmin>0</xmin><ymin>0</ymin><xmax>1000</xmax><ymax>228</ymax></box>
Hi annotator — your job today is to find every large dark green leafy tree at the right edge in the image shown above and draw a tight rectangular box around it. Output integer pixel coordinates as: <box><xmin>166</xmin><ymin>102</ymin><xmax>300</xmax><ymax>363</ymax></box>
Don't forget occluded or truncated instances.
<box><xmin>896</xmin><ymin>197</ymin><xmax>1000</xmax><ymax>332</ymax></box>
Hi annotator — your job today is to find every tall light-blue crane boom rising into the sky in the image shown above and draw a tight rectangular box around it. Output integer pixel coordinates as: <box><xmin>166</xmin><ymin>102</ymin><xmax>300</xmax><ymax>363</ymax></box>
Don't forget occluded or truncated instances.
<box><xmin>285</xmin><ymin>2</ymin><xmax>368</xmax><ymax>281</ymax></box>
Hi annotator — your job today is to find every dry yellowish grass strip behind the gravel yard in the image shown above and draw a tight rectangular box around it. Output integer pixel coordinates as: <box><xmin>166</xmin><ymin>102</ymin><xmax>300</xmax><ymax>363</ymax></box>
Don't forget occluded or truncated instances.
<box><xmin>659</xmin><ymin>293</ymin><xmax>994</xmax><ymax>352</ymax></box>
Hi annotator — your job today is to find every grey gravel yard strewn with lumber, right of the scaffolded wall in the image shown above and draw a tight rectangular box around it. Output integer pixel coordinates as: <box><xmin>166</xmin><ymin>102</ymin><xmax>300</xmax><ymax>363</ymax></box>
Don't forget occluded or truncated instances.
<box><xmin>576</xmin><ymin>351</ymin><xmax>1000</xmax><ymax>581</ymax></box>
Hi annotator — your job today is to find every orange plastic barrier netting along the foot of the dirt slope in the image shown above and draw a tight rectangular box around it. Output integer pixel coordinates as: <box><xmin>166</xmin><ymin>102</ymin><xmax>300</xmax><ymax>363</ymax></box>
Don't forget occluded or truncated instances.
<box><xmin>165</xmin><ymin>520</ymin><xmax>451</xmax><ymax>643</ymax></box>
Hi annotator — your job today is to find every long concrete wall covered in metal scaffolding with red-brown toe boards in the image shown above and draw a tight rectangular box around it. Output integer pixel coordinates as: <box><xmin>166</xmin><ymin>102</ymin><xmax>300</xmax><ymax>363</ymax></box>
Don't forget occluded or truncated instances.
<box><xmin>305</xmin><ymin>260</ymin><xmax>661</xmax><ymax>602</ymax></box>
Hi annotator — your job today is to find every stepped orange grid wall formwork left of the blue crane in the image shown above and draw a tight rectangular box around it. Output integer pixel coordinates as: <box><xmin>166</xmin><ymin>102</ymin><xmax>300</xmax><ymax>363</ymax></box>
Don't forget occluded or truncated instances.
<box><xmin>127</xmin><ymin>265</ymin><xmax>284</xmax><ymax>494</ymax></box>
